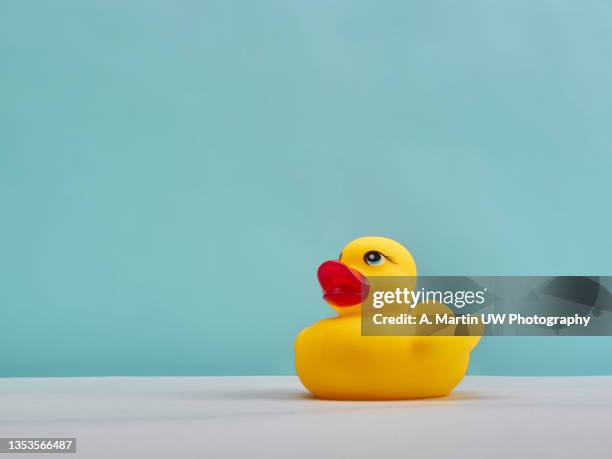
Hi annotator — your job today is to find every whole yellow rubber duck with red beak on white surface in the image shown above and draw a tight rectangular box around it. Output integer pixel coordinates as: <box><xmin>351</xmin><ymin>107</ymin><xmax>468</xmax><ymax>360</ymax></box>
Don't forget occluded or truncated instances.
<box><xmin>295</xmin><ymin>237</ymin><xmax>480</xmax><ymax>400</ymax></box>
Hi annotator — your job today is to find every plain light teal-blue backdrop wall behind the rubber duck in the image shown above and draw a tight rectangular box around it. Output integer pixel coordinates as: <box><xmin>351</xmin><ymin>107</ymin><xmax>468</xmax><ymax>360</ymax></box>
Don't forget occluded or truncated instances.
<box><xmin>0</xmin><ymin>0</ymin><xmax>612</xmax><ymax>376</ymax></box>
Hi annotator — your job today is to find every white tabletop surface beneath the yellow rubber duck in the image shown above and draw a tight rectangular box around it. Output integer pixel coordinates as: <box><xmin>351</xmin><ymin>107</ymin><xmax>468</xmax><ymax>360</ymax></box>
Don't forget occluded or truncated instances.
<box><xmin>0</xmin><ymin>377</ymin><xmax>612</xmax><ymax>459</ymax></box>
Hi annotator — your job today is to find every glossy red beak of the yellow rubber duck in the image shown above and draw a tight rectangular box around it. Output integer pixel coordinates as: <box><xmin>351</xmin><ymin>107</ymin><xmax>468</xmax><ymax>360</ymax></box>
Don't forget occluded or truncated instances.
<box><xmin>317</xmin><ymin>261</ymin><xmax>370</xmax><ymax>308</ymax></box>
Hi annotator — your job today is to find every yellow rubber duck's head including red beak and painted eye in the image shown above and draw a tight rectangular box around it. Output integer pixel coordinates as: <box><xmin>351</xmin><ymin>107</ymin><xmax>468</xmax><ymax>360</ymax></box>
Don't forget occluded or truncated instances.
<box><xmin>317</xmin><ymin>236</ymin><xmax>417</xmax><ymax>316</ymax></box>
